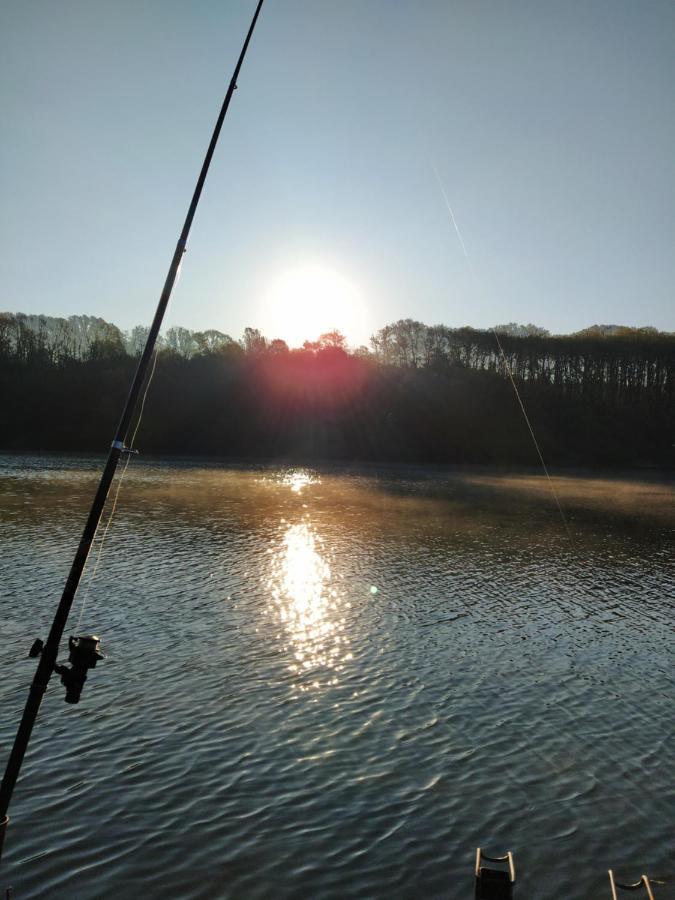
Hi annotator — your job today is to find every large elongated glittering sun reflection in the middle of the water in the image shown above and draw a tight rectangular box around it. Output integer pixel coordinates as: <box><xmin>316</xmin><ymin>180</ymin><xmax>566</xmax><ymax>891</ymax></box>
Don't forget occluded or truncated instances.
<box><xmin>268</xmin><ymin>521</ymin><xmax>352</xmax><ymax>691</ymax></box>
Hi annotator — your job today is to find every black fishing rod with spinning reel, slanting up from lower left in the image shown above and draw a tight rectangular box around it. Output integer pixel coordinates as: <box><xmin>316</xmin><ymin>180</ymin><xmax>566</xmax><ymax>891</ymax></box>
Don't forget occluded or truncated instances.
<box><xmin>0</xmin><ymin>0</ymin><xmax>263</xmax><ymax>858</ymax></box>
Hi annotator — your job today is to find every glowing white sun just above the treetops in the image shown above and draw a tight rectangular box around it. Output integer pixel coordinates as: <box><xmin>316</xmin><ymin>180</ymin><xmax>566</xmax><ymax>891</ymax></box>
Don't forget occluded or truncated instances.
<box><xmin>262</xmin><ymin>265</ymin><xmax>368</xmax><ymax>347</ymax></box>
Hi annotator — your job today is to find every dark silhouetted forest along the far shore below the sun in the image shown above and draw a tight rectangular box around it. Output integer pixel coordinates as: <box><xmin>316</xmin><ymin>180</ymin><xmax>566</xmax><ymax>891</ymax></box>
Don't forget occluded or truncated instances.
<box><xmin>0</xmin><ymin>313</ymin><xmax>675</xmax><ymax>467</ymax></box>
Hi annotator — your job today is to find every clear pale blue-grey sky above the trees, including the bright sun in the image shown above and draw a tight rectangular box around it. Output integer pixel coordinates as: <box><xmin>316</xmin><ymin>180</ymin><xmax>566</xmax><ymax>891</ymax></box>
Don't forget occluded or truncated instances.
<box><xmin>0</xmin><ymin>0</ymin><xmax>675</xmax><ymax>344</ymax></box>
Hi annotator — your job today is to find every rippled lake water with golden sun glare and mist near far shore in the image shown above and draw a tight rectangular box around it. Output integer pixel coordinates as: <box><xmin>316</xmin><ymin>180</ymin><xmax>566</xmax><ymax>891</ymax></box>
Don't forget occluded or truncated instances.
<box><xmin>0</xmin><ymin>456</ymin><xmax>675</xmax><ymax>900</ymax></box>
